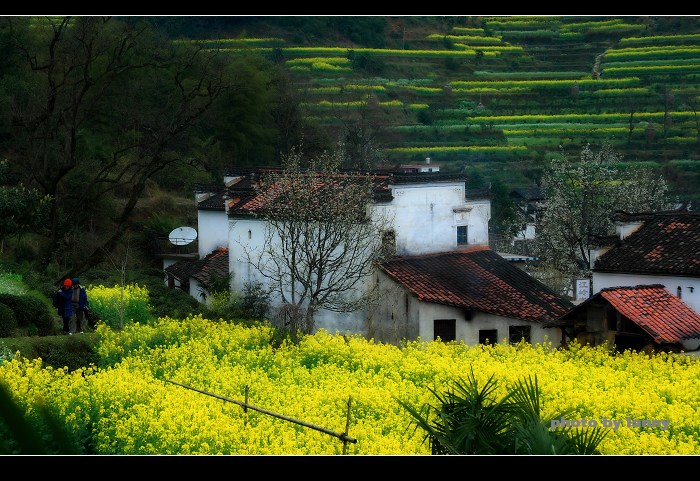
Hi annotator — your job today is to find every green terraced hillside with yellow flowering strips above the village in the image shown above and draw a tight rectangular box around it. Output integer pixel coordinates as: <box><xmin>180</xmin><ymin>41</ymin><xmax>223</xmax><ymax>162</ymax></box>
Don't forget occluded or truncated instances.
<box><xmin>193</xmin><ymin>17</ymin><xmax>700</xmax><ymax>200</ymax></box>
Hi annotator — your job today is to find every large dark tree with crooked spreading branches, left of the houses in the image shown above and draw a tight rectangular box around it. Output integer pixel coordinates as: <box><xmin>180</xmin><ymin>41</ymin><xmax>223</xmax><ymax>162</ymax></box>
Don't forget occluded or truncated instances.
<box><xmin>0</xmin><ymin>17</ymin><xmax>266</xmax><ymax>276</ymax></box>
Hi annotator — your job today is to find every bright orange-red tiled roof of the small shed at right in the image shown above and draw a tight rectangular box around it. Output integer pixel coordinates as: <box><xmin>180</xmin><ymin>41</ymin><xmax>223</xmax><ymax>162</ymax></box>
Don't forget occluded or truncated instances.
<box><xmin>598</xmin><ymin>284</ymin><xmax>700</xmax><ymax>343</ymax></box>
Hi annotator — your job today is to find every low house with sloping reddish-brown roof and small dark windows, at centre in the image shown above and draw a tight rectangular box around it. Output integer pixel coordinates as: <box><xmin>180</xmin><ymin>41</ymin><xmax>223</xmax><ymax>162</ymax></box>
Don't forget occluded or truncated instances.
<box><xmin>369</xmin><ymin>245</ymin><xmax>573</xmax><ymax>346</ymax></box>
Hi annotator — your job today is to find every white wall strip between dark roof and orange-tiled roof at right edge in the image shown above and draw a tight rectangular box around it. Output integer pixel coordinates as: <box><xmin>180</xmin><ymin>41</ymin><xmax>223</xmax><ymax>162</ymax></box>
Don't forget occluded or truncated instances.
<box><xmin>592</xmin><ymin>272</ymin><xmax>700</xmax><ymax>314</ymax></box>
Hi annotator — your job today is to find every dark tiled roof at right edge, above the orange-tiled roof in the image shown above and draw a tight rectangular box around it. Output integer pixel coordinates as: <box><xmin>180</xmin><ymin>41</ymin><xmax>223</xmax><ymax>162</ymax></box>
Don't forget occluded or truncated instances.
<box><xmin>594</xmin><ymin>212</ymin><xmax>700</xmax><ymax>277</ymax></box>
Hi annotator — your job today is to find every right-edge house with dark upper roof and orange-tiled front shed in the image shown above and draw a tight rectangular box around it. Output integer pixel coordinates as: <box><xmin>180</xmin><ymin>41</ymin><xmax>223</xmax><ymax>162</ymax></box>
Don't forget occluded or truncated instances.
<box><xmin>548</xmin><ymin>210</ymin><xmax>700</xmax><ymax>352</ymax></box>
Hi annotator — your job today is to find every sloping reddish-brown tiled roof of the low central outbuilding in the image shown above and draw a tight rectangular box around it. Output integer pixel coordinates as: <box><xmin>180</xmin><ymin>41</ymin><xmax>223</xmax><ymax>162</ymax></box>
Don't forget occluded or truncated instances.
<box><xmin>380</xmin><ymin>246</ymin><xmax>572</xmax><ymax>322</ymax></box>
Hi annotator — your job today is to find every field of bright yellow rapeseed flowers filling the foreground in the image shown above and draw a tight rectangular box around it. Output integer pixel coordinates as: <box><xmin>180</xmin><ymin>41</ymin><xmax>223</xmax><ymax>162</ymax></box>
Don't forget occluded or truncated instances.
<box><xmin>0</xmin><ymin>316</ymin><xmax>700</xmax><ymax>455</ymax></box>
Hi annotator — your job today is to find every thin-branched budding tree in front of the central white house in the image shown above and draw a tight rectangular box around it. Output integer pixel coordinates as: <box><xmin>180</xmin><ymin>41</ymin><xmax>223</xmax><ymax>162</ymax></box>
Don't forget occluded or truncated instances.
<box><xmin>248</xmin><ymin>145</ymin><xmax>388</xmax><ymax>333</ymax></box>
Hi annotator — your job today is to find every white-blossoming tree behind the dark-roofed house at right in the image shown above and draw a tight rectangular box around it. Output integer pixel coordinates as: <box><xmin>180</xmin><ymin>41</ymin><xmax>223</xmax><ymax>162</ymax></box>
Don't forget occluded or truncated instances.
<box><xmin>536</xmin><ymin>143</ymin><xmax>671</xmax><ymax>284</ymax></box>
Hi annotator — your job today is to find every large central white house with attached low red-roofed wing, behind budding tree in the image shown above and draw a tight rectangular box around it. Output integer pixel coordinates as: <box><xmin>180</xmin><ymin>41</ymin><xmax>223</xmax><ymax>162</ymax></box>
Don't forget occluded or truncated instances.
<box><xmin>166</xmin><ymin>168</ymin><xmax>570</xmax><ymax>344</ymax></box>
